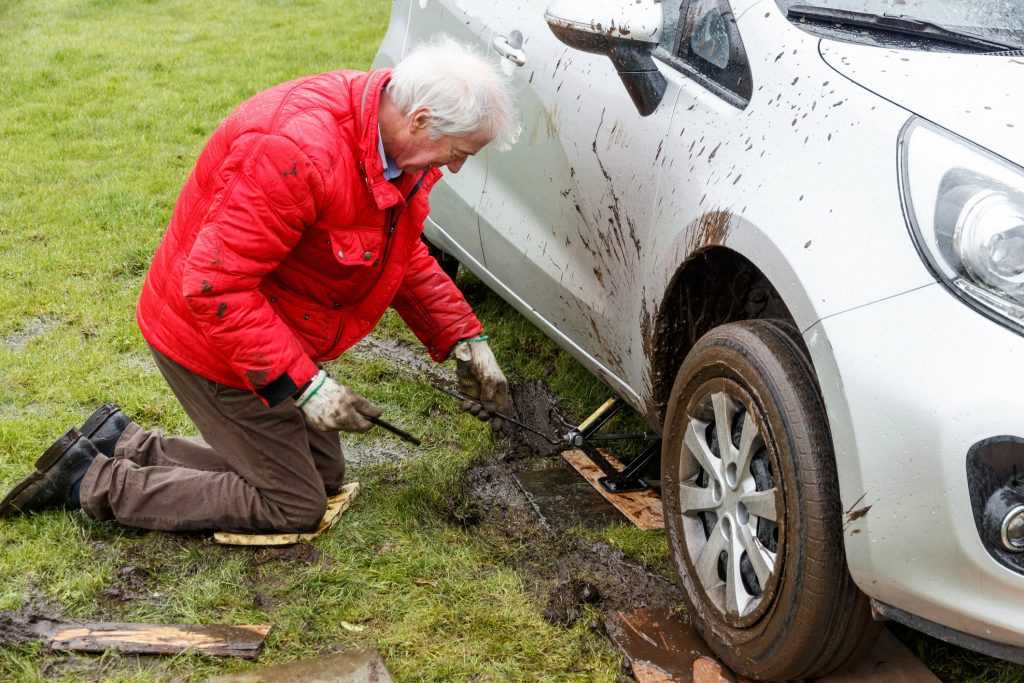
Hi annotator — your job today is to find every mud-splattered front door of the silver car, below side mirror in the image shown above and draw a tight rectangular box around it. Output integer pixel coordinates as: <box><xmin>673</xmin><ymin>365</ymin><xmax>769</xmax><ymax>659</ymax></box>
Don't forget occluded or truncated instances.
<box><xmin>479</xmin><ymin>0</ymin><xmax>678</xmax><ymax>383</ymax></box>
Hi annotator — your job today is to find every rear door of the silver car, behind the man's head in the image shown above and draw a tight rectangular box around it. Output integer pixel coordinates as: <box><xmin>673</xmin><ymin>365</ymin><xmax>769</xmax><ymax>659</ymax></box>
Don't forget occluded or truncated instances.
<box><xmin>374</xmin><ymin>0</ymin><xmax>495</xmax><ymax>261</ymax></box>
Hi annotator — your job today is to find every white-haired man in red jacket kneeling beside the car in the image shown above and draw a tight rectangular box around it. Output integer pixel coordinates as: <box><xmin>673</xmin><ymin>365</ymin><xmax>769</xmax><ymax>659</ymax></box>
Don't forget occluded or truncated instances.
<box><xmin>0</xmin><ymin>40</ymin><xmax>518</xmax><ymax>531</ymax></box>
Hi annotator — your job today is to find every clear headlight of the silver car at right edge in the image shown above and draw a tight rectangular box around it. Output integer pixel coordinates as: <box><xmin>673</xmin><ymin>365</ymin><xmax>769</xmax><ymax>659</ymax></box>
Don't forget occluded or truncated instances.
<box><xmin>899</xmin><ymin>117</ymin><xmax>1024</xmax><ymax>334</ymax></box>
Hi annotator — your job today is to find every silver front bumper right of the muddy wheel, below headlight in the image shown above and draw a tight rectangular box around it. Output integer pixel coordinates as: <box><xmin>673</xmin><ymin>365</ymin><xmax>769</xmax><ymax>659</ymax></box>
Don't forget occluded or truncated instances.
<box><xmin>805</xmin><ymin>285</ymin><xmax>1024</xmax><ymax>647</ymax></box>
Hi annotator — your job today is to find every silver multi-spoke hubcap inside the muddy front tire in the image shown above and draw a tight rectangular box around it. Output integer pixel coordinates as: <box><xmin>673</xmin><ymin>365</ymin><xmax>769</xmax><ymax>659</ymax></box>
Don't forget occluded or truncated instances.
<box><xmin>678</xmin><ymin>386</ymin><xmax>781</xmax><ymax>622</ymax></box>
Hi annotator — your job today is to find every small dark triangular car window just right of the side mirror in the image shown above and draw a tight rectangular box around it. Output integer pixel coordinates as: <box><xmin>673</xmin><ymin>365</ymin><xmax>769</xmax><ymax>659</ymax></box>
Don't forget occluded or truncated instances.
<box><xmin>658</xmin><ymin>0</ymin><xmax>753</xmax><ymax>106</ymax></box>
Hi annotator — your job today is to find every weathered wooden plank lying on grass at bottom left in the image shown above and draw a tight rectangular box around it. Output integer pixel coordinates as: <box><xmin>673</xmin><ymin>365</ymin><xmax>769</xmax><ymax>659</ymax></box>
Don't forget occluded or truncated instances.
<box><xmin>33</xmin><ymin>622</ymin><xmax>270</xmax><ymax>659</ymax></box>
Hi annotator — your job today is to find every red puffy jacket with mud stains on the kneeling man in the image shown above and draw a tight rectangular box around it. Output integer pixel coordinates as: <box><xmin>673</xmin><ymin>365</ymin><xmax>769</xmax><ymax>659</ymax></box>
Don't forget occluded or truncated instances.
<box><xmin>137</xmin><ymin>70</ymin><xmax>482</xmax><ymax>404</ymax></box>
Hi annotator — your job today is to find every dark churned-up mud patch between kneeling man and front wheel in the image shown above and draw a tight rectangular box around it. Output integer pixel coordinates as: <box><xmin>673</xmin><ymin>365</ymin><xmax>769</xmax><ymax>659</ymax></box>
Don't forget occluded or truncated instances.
<box><xmin>453</xmin><ymin>381</ymin><xmax>682</xmax><ymax>627</ymax></box>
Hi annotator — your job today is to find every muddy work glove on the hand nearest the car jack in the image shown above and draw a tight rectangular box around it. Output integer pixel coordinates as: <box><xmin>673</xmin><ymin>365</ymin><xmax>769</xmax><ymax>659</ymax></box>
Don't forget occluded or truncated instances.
<box><xmin>455</xmin><ymin>337</ymin><xmax>512</xmax><ymax>429</ymax></box>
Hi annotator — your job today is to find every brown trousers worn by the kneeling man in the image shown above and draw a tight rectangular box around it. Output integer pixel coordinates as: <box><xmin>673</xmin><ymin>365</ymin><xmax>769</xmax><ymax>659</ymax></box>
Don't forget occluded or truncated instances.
<box><xmin>81</xmin><ymin>349</ymin><xmax>345</xmax><ymax>531</ymax></box>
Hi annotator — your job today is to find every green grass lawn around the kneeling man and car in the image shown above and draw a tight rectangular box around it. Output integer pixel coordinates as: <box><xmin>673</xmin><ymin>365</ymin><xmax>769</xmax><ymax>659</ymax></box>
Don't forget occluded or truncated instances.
<box><xmin>0</xmin><ymin>0</ymin><xmax>1024</xmax><ymax>683</ymax></box>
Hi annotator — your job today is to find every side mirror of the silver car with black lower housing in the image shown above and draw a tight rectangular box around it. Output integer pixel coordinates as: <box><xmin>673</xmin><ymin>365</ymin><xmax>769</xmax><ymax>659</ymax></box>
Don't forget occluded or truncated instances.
<box><xmin>544</xmin><ymin>0</ymin><xmax>668</xmax><ymax>116</ymax></box>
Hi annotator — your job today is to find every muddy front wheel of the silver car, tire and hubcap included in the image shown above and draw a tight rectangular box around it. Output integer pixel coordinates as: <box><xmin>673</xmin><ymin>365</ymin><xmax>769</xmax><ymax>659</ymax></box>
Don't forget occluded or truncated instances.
<box><xmin>662</xmin><ymin>321</ymin><xmax>881</xmax><ymax>681</ymax></box>
